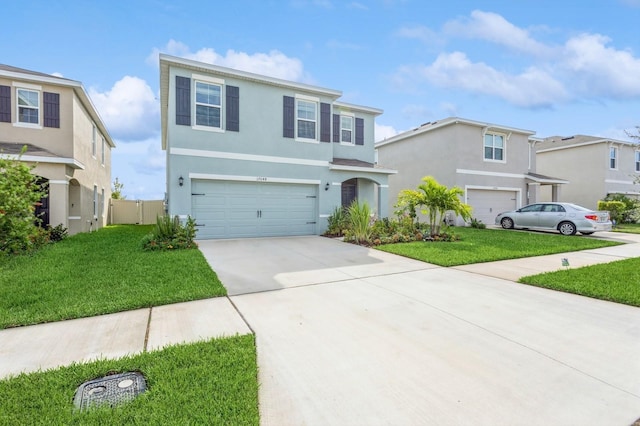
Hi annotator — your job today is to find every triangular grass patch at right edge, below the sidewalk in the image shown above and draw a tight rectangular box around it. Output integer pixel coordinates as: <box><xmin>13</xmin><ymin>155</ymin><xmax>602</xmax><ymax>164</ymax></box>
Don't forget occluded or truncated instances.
<box><xmin>518</xmin><ymin>258</ymin><xmax>640</xmax><ymax>306</ymax></box>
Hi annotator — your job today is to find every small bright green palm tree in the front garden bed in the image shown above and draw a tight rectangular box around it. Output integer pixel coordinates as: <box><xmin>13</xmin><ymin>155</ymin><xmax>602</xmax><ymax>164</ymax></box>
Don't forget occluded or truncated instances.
<box><xmin>398</xmin><ymin>176</ymin><xmax>471</xmax><ymax>236</ymax></box>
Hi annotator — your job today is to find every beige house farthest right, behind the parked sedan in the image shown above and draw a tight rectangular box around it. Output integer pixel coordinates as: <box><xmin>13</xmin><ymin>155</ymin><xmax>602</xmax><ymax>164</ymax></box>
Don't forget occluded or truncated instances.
<box><xmin>536</xmin><ymin>135</ymin><xmax>640</xmax><ymax>209</ymax></box>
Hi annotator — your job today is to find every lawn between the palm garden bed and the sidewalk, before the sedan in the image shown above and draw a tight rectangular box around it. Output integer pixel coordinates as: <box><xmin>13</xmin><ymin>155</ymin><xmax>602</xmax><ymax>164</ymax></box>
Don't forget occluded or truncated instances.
<box><xmin>376</xmin><ymin>227</ymin><xmax>620</xmax><ymax>266</ymax></box>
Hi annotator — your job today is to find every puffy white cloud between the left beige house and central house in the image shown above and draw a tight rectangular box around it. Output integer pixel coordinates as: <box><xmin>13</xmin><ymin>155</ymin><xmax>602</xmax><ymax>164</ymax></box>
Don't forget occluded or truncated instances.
<box><xmin>89</xmin><ymin>76</ymin><xmax>160</xmax><ymax>141</ymax></box>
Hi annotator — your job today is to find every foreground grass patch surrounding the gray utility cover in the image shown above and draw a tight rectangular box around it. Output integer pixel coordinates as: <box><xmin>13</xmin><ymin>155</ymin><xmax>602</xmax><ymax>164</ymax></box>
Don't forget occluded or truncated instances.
<box><xmin>0</xmin><ymin>335</ymin><xmax>259</xmax><ymax>426</ymax></box>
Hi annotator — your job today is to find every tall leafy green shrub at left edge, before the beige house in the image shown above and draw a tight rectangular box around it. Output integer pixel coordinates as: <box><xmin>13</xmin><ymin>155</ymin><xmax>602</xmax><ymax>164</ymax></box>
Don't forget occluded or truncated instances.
<box><xmin>0</xmin><ymin>146</ymin><xmax>46</xmax><ymax>254</ymax></box>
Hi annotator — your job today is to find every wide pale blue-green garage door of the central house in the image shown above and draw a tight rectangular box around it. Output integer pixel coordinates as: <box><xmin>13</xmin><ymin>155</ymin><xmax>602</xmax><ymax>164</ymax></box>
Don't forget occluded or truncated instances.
<box><xmin>191</xmin><ymin>180</ymin><xmax>317</xmax><ymax>239</ymax></box>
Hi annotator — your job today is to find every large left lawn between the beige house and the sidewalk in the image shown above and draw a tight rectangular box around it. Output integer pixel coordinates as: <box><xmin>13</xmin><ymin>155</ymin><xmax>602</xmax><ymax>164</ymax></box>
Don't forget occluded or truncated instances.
<box><xmin>0</xmin><ymin>225</ymin><xmax>226</xmax><ymax>329</ymax></box>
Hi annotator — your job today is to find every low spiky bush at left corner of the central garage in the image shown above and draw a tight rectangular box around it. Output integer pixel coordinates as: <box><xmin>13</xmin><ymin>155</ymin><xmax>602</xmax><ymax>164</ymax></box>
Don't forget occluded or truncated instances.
<box><xmin>142</xmin><ymin>215</ymin><xmax>198</xmax><ymax>250</ymax></box>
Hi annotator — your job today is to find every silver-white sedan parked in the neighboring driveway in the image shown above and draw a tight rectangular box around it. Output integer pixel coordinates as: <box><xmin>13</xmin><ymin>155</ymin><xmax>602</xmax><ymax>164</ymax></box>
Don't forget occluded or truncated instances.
<box><xmin>496</xmin><ymin>203</ymin><xmax>612</xmax><ymax>235</ymax></box>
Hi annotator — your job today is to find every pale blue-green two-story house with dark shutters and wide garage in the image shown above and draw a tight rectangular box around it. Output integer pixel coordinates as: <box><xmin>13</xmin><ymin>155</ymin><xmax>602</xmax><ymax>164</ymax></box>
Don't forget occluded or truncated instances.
<box><xmin>160</xmin><ymin>54</ymin><xmax>394</xmax><ymax>238</ymax></box>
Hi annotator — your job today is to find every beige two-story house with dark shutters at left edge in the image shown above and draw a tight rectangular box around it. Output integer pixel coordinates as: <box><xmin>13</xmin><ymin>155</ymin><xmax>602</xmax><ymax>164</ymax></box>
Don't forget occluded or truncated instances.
<box><xmin>0</xmin><ymin>65</ymin><xmax>115</xmax><ymax>234</ymax></box>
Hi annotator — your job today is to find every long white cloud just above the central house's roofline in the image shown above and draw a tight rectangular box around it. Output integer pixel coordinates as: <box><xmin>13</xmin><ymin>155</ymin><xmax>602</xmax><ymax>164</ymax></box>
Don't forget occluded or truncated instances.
<box><xmin>147</xmin><ymin>40</ymin><xmax>313</xmax><ymax>83</ymax></box>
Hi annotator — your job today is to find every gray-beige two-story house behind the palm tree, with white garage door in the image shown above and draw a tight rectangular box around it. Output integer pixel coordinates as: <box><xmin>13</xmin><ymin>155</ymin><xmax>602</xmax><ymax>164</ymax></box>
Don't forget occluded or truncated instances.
<box><xmin>376</xmin><ymin>117</ymin><xmax>565</xmax><ymax>225</ymax></box>
